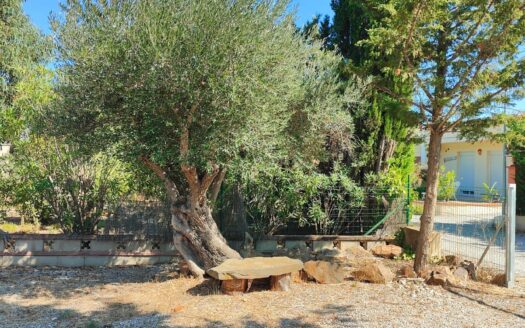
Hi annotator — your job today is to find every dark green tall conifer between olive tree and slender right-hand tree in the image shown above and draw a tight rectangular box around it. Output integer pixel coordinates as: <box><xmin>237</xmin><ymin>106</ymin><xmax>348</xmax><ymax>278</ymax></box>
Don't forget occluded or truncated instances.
<box><xmin>304</xmin><ymin>0</ymin><xmax>417</xmax><ymax>187</ymax></box>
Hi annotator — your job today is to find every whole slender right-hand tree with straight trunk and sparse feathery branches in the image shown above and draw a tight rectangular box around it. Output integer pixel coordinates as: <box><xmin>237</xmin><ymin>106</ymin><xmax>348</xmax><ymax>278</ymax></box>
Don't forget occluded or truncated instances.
<box><xmin>366</xmin><ymin>0</ymin><xmax>525</xmax><ymax>273</ymax></box>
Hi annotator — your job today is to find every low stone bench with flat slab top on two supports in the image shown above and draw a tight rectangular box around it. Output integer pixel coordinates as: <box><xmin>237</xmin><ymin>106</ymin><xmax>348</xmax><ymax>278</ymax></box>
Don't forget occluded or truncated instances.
<box><xmin>207</xmin><ymin>257</ymin><xmax>303</xmax><ymax>295</ymax></box>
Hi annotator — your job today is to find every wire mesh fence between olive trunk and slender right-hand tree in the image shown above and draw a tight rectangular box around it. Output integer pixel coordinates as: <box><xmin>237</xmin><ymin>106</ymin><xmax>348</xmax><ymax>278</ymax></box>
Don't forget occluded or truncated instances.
<box><xmin>216</xmin><ymin>188</ymin><xmax>407</xmax><ymax>240</ymax></box>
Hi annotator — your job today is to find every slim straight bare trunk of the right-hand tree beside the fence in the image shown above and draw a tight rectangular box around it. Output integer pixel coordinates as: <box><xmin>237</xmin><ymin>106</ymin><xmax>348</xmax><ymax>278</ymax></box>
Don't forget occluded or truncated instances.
<box><xmin>414</xmin><ymin>129</ymin><xmax>443</xmax><ymax>274</ymax></box>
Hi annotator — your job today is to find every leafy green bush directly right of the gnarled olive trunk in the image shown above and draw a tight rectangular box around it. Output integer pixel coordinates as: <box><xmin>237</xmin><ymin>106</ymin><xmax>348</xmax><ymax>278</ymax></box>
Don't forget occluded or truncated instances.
<box><xmin>237</xmin><ymin>166</ymin><xmax>364</xmax><ymax>235</ymax></box>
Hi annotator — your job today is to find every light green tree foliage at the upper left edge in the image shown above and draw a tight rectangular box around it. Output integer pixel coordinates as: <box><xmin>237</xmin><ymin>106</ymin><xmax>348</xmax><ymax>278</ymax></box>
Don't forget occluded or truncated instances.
<box><xmin>0</xmin><ymin>0</ymin><xmax>51</xmax><ymax>142</ymax></box>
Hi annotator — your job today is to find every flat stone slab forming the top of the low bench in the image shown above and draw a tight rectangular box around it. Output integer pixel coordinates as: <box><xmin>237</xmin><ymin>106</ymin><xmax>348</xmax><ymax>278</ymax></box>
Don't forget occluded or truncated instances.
<box><xmin>206</xmin><ymin>256</ymin><xmax>303</xmax><ymax>280</ymax></box>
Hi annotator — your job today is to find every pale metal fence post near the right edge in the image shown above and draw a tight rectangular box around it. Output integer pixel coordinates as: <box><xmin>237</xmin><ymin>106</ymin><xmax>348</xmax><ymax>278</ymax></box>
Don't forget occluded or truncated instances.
<box><xmin>505</xmin><ymin>184</ymin><xmax>516</xmax><ymax>288</ymax></box>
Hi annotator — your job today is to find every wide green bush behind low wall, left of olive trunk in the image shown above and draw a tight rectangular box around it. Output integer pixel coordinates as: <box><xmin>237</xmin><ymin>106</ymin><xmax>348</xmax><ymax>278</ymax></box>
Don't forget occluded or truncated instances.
<box><xmin>0</xmin><ymin>138</ymin><xmax>131</xmax><ymax>234</ymax></box>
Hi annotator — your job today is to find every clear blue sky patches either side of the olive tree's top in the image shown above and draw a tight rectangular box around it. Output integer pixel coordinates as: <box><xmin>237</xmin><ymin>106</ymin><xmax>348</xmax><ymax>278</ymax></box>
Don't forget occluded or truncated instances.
<box><xmin>24</xmin><ymin>0</ymin><xmax>332</xmax><ymax>33</ymax></box>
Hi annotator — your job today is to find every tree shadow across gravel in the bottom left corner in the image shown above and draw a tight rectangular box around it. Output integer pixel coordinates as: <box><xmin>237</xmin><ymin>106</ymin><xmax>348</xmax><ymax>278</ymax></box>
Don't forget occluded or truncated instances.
<box><xmin>0</xmin><ymin>301</ymin><xmax>170</xmax><ymax>328</ymax></box>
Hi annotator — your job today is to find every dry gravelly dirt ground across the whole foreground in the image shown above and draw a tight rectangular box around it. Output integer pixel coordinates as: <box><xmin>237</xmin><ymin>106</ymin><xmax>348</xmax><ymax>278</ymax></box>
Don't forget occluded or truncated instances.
<box><xmin>0</xmin><ymin>263</ymin><xmax>525</xmax><ymax>328</ymax></box>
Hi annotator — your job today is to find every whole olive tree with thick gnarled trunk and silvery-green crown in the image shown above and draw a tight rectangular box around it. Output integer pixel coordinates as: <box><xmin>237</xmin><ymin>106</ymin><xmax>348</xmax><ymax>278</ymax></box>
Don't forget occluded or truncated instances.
<box><xmin>50</xmin><ymin>0</ymin><xmax>364</xmax><ymax>275</ymax></box>
